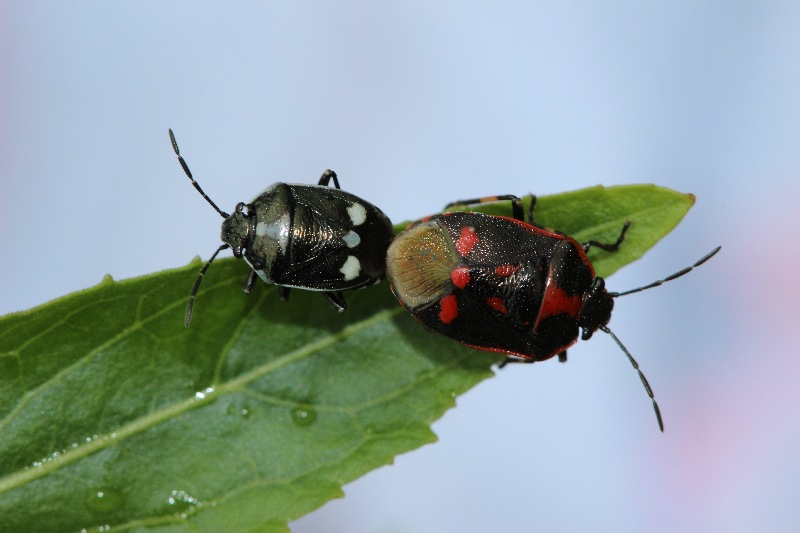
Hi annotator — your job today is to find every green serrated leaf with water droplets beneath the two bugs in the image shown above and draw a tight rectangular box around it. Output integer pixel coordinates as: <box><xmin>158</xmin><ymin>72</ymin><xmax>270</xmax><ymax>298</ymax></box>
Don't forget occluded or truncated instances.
<box><xmin>0</xmin><ymin>186</ymin><xmax>692</xmax><ymax>531</ymax></box>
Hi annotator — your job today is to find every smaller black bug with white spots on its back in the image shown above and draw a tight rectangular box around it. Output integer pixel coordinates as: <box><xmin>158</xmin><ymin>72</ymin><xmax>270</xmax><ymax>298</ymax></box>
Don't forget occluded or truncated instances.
<box><xmin>169</xmin><ymin>130</ymin><xmax>394</xmax><ymax>327</ymax></box>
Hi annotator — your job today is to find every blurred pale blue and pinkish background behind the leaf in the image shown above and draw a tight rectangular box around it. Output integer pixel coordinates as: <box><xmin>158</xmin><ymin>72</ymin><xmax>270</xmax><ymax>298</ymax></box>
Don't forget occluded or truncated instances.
<box><xmin>0</xmin><ymin>0</ymin><xmax>800</xmax><ymax>533</ymax></box>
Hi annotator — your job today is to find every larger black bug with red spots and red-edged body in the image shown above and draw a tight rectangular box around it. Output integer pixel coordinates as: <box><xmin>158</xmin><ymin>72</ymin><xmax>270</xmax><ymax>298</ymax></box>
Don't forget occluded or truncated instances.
<box><xmin>386</xmin><ymin>195</ymin><xmax>719</xmax><ymax>431</ymax></box>
